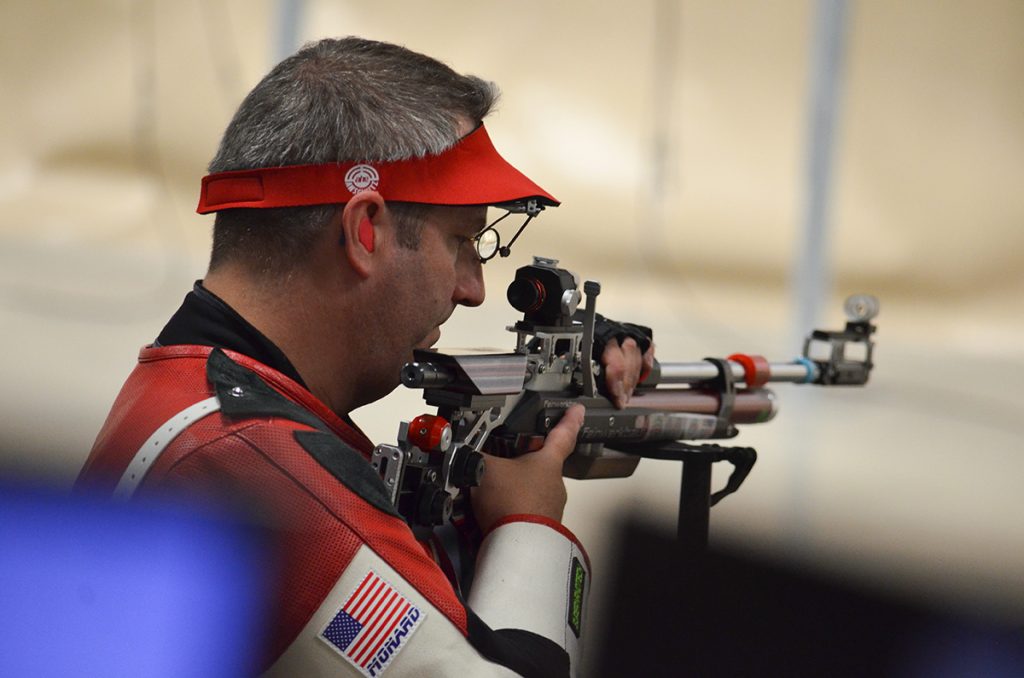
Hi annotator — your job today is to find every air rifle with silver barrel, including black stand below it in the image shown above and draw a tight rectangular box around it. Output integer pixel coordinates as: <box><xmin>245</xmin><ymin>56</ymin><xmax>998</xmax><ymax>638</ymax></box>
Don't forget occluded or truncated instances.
<box><xmin>372</xmin><ymin>257</ymin><xmax>879</xmax><ymax>544</ymax></box>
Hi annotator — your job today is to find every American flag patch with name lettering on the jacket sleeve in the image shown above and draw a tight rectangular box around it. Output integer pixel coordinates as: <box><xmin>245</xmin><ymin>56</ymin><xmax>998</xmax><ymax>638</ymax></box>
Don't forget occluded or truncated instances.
<box><xmin>319</xmin><ymin>569</ymin><xmax>425</xmax><ymax>677</ymax></box>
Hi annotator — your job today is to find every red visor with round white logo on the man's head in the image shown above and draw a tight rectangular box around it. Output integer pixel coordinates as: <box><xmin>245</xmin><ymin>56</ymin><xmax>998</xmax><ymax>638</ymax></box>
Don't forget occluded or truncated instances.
<box><xmin>196</xmin><ymin>125</ymin><xmax>558</xmax><ymax>214</ymax></box>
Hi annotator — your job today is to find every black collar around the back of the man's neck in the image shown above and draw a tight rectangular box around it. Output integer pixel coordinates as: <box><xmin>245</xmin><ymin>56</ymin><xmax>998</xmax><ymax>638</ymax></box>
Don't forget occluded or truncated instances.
<box><xmin>154</xmin><ymin>281</ymin><xmax>306</xmax><ymax>388</ymax></box>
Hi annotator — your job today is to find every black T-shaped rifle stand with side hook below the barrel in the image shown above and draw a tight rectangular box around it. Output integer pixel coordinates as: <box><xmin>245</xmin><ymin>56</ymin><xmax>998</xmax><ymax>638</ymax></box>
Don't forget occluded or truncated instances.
<box><xmin>620</xmin><ymin>442</ymin><xmax>758</xmax><ymax>552</ymax></box>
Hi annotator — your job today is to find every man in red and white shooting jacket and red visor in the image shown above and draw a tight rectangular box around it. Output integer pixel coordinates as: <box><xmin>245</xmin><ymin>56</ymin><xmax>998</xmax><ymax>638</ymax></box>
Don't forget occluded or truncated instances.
<box><xmin>79</xmin><ymin>38</ymin><xmax>652</xmax><ymax>676</ymax></box>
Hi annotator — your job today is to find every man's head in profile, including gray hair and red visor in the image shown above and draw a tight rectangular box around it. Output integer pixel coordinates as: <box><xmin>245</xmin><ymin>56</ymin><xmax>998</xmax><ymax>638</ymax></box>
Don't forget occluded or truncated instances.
<box><xmin>199</xmin><ymin>38</ymin><xmax>558</xmax><ymax>412</ymax></box>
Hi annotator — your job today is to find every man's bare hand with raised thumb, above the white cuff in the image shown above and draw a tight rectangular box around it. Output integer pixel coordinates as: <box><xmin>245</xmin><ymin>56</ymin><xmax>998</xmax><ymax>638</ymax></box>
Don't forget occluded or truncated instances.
<box><xmin>472</xmin><ymin>405</ymin><xmax>585</xmax><ymax>533</ymax></box>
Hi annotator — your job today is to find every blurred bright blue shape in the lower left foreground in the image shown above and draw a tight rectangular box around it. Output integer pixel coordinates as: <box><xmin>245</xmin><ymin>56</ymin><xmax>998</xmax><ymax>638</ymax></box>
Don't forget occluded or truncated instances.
<box><xmin>0</xmin><ymin>481</ymin><xmax>269</xmax><ymax>678</ymax></box>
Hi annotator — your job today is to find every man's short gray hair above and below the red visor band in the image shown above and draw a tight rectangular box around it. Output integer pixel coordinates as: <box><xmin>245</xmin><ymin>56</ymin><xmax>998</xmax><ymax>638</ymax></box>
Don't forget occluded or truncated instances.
<box><xmin>209</xmin><ymin>37</ymin><xmax>498</xmax><ymax>274</ymax></box>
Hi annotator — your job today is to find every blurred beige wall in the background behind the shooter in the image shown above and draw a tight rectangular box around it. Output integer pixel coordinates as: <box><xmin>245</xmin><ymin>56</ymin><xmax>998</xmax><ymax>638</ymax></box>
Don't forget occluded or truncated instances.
<box><xmin>0</xmin><ymin>0</ymin><xmax>1024</xmax><ymax>659</ymax></box>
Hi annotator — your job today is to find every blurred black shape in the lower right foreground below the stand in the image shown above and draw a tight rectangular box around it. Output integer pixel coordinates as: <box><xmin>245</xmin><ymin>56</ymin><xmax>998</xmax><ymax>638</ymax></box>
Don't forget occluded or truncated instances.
<box><xmin>589</xmin><ymin>521</ymin><xmax>1024</xmax><ymax>678</ymax></box>
